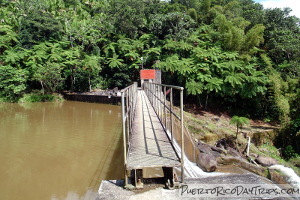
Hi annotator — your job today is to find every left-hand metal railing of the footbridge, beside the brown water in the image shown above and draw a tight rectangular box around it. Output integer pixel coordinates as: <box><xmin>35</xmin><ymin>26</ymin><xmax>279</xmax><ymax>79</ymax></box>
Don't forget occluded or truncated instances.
<box><xmin>121</xmin><ymin>82</ymin><xmax>137</xmax><ymax>185</ymax></box>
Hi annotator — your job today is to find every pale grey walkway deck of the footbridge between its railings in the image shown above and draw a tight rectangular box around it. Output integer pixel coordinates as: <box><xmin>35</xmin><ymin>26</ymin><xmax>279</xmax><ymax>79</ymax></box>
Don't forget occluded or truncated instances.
<box><xmin>127</xmin><ymin>90</ymin><xmax>180</xmax><ymax>169</ymax></box>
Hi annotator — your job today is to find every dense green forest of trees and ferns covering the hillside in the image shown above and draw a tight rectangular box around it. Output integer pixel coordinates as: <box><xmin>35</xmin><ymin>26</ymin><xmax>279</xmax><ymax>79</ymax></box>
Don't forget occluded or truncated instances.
<box><xmin>0</xmin><ymin>0</ymin><xmax>300</xmax><ymax>152</ymax></box>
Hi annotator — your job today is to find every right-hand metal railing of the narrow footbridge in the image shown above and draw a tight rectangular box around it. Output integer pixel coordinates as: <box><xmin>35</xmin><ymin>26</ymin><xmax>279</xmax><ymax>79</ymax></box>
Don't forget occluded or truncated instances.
<box><xmin>144</xmin><ymin>82</ymin><xmax>185</xmax><ymax>182</ymax></box>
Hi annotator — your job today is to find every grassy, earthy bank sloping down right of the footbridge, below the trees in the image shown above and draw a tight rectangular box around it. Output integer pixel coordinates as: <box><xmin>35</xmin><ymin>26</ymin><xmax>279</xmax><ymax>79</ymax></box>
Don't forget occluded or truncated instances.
<box><xmin>185</xmin><ymin>111</ymin><xmax>300</xmax><ymax>176</ymax></box>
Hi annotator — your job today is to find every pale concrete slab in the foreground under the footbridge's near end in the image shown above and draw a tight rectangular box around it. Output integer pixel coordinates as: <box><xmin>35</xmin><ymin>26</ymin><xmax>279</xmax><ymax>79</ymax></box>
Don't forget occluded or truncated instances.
<box><xmin>96</xmin><ymin>172</ymin><xmax>292</xmax><ymax>200</ymax></box>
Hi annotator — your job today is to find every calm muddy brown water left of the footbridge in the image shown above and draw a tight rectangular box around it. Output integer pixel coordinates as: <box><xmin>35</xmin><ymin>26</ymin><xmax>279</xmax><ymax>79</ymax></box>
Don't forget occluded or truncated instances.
<box><xmin>0</xmin><ymin>101</ymin><xmax>124</xmax><ymax>200</ymax></box>
